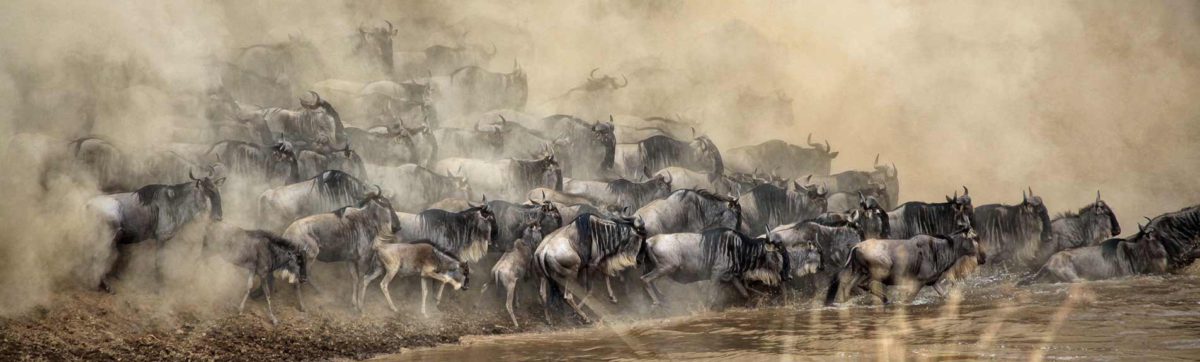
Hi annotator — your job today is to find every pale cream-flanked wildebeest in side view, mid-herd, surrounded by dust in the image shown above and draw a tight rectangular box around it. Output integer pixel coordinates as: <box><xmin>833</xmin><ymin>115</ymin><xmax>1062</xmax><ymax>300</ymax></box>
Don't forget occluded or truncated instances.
<box><xmin>433</xmin><ymin>155</ymin><xmax>563</xmax><ymax>200</ymax></box>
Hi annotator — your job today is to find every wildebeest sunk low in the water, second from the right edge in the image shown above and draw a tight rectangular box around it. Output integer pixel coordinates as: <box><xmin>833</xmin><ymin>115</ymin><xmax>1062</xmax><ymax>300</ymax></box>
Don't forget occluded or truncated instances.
<box><xmin>1019</xmin><ymin>225</ymin><xmax>1168</xmax><ymax>285</ymax></box>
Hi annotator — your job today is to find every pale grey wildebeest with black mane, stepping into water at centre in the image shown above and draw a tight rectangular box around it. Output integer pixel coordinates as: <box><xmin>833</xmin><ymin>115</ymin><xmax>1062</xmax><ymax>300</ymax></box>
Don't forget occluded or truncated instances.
<box><xmin>641</xmin><ymin>228</ymin><xmax>791</xmax><ymax>306</ymax></box>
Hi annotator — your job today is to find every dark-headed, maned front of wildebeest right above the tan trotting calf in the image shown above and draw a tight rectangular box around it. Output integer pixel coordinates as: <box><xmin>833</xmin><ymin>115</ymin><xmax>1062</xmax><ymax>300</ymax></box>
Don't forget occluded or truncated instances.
<box><xmin>413</xmin><ymin>206</ymin><xmax>499</xmax><ymax>261</ymax></box>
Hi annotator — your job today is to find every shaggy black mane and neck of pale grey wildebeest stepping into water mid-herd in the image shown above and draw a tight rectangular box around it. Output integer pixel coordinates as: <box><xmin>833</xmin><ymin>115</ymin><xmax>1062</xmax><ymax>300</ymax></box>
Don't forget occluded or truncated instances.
<box><xmin>700</xmin><ymin>228</ymin><xmax>790</xmax><ymax>284</ymax></box>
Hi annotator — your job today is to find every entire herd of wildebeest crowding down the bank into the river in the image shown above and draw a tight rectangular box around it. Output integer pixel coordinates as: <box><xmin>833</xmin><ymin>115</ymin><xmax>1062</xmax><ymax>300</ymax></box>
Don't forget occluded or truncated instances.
<box><xmin>21</xmin><ymin>23</ymin><xmax>1200</xmax><ymax>324</ymax></box>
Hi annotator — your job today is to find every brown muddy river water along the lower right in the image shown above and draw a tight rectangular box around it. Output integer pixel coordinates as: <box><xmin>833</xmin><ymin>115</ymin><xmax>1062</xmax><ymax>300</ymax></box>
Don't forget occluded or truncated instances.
<box><xmin>380</xmin><ymin>276</ymin><xmax>1200</xmax><ymax>361</ymax></box>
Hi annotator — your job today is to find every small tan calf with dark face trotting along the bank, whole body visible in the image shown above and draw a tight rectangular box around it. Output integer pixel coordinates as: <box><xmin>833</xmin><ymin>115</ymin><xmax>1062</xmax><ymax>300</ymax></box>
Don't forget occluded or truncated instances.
<box><xmin>356</xmin><ymin>240</ymin><xmax>470</xmax><ymax>315</ymax></box>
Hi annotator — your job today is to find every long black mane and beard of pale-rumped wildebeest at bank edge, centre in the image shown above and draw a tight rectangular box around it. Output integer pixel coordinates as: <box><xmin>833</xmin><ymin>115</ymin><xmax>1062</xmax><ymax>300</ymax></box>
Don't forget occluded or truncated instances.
<box><xmin>574</xmin><ymin>213</ymin><xmax>642</xmax><ymax>278</ymax></box>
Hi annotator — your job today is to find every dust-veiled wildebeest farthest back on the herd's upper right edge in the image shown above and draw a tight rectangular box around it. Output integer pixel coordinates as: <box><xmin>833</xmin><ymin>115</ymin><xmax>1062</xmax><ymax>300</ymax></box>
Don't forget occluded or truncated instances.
<box><xmin>726</xmin><ymin>134</ymin><xmax>844</xmax><ymax>178</ymax></box>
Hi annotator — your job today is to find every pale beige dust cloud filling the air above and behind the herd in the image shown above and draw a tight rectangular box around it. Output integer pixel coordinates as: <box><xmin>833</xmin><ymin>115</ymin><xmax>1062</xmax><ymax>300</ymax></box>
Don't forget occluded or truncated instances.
<box><xmin>0</xmin><ymin>1</ymin><xmax>1200</xmax><ymax>314</ymax></box>
